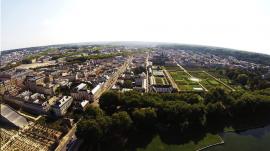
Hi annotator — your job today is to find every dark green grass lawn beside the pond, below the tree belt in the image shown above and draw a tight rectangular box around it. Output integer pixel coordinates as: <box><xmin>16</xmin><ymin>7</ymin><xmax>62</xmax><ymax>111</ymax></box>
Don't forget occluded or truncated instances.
<box><xmin>137</xmin><ymin>133</ymin><xmax>222</xmax><ymax>151</ymax></box>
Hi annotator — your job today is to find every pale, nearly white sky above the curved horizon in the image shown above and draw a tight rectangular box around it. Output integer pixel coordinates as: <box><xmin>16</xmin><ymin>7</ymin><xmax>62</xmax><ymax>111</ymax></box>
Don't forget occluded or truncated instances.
<box><xmin>1</xmin><ymin>0</ymin><xmax>270</xmax><ymax>54</ymax></box>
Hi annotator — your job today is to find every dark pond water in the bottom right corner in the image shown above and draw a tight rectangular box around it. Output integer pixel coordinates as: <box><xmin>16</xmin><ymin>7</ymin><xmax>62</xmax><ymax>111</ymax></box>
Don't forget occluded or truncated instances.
<box><xmin>206</xmin><ymin>125</ymin><xmax>270</xmax><ymax>151</ymax></box>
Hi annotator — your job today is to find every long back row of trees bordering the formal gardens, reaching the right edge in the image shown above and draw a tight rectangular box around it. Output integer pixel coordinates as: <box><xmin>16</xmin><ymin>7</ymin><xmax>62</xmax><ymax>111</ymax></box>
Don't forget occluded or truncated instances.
<box><xmin>99</xmin><ymin>88</ymin><xmax>270</xmax><ymax>130</ymax></box>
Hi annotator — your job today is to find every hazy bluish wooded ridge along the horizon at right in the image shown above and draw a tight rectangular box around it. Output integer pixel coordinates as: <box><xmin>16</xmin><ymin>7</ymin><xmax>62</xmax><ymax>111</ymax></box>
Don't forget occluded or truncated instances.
<box><xmin>159</xmin><ymin>45</ymin><xmax>270</xmax><ymax>66</ymax></box>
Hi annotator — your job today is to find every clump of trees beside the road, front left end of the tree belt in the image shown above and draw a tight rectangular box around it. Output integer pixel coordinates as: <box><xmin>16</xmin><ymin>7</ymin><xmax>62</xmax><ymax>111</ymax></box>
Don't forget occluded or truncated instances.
<box><xmin>76</xmin><ymin>107</ymin><xmax>133</xmax><ymax>149</ymax></box>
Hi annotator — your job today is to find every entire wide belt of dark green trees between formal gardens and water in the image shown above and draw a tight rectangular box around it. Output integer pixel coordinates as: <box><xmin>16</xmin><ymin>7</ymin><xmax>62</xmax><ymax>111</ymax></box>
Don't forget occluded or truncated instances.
<box><xmin>76</xmin><ymin>88</ymin><xmax>270</xmax><ymax>150</ymax></box>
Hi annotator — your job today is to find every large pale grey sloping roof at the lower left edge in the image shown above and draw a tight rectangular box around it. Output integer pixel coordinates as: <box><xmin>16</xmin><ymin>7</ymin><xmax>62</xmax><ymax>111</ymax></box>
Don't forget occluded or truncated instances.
<box><xmin>0</xmin><ymin>104</ymin><xmax>28</xmax><ymax>128</ymax></box>
